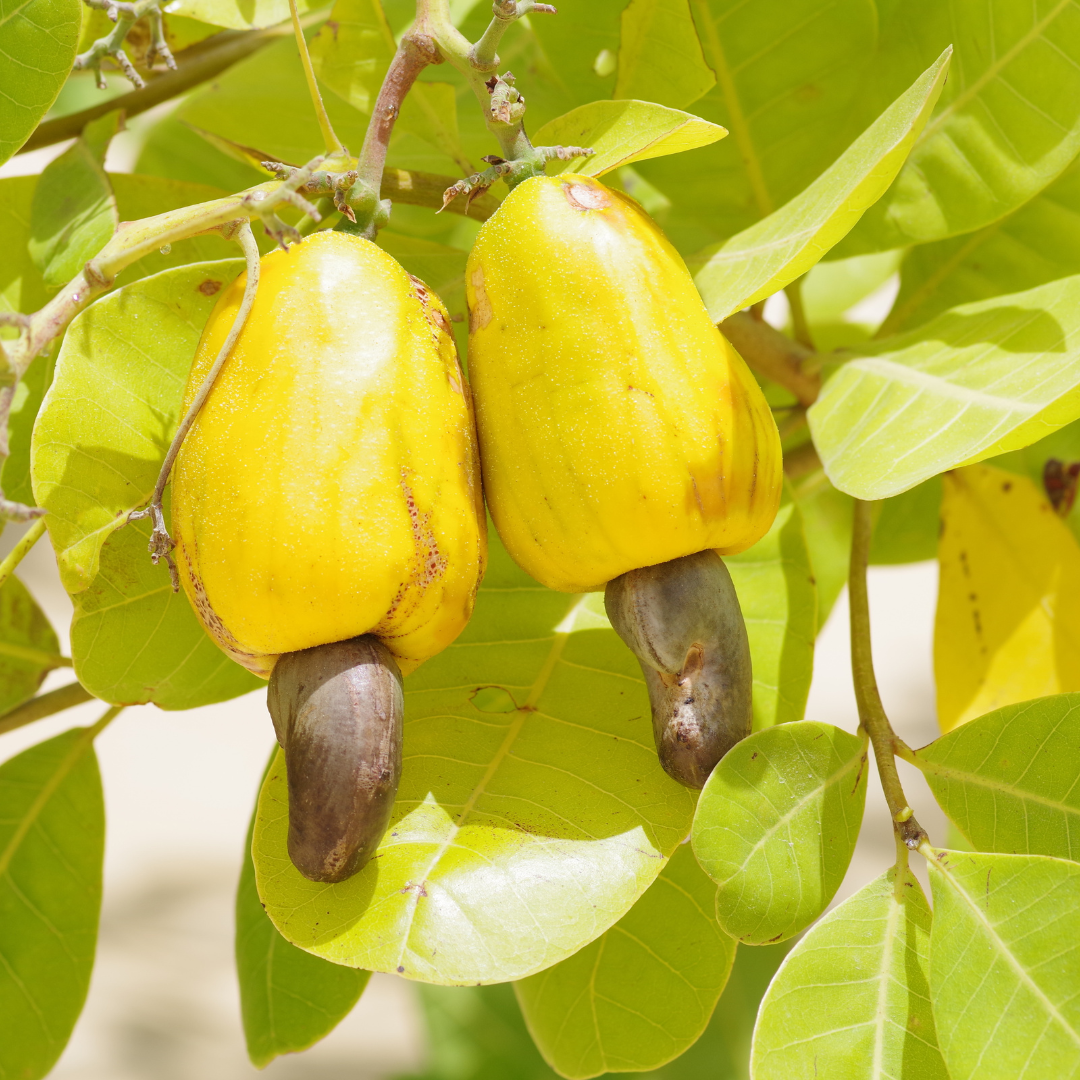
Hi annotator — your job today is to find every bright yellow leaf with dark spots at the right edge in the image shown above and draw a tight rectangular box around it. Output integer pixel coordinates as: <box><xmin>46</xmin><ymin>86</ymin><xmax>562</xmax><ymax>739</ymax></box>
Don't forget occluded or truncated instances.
<box><xmin>934</xmin><ymin>465</ymin><xmax>1080</xmax><ymax>731</ymax></box>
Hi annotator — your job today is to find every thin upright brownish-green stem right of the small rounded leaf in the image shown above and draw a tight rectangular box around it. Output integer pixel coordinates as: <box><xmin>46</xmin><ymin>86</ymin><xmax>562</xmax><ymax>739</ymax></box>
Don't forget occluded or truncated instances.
<box><xmin>848</xmin><ymin>499</ymin><xmax>927</xmax><ymax>850</ymax></box>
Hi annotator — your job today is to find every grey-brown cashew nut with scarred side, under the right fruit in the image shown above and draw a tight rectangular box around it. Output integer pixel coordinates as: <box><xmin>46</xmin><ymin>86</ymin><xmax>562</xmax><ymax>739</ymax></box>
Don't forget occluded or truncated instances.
<box><xmin>604</xmin><ymin>551</ymin><xmax>754</xmax><ymax>788</ymax></box>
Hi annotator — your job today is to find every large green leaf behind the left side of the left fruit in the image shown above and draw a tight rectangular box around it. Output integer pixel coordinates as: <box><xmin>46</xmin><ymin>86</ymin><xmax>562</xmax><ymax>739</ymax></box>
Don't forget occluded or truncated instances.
<box><xmin>31</xmin><ymin>259</ymin><xmax>261</xmax><ymax>708</ymax></box>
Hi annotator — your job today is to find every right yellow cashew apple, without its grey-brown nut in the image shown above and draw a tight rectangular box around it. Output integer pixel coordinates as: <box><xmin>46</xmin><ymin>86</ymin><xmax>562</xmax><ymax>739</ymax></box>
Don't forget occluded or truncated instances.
<box><xmin>465</xmin><ymin>174</ymin><xmax>782</xmax><ymax>592</ymax></box>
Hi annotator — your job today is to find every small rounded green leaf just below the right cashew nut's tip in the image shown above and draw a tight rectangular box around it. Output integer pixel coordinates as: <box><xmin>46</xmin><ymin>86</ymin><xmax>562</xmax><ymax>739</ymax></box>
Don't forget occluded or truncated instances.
<box><xmin>693</xmin><ymin>720</ymin><xmax>866</xmax><ymax>945</ymax></box>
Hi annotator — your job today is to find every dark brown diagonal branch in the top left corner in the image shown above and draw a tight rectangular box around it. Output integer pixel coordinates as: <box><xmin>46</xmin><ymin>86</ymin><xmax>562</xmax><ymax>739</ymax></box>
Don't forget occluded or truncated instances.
<box><xmin>18</xmin><ymin>26</ymin><xmax>292</xmax><ymax>153</ymax></box>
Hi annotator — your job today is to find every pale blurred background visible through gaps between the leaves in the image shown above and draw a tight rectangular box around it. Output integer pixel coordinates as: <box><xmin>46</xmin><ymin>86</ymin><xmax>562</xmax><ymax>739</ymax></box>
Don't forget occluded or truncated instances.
<box><xmin>0</xmin><ymin>124</ymin><xmax>946</xmax><ymax>1080</ymax></box>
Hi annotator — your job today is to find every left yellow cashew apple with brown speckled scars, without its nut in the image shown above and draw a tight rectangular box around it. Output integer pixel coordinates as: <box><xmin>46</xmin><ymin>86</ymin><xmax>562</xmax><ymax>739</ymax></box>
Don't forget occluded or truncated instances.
<box><xmin>172</xmin><ymin>232</ymin><xmax>487</xmax><ymax>678</ymax></box>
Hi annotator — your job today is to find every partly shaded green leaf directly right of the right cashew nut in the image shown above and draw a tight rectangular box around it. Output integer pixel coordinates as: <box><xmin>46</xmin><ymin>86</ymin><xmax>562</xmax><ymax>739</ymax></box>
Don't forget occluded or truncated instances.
<box><xmin>724</xmin><ymin>502</ymin><xmax>818</xmax><ymax>730</ymax></box>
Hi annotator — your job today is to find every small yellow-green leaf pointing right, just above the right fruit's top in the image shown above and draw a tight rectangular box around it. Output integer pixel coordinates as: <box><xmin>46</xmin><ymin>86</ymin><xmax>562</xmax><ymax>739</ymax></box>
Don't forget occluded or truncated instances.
<box><xmin>534</xmin><ymin>102</ymin><xmax>727</xmax><ymax>176</ymax></box>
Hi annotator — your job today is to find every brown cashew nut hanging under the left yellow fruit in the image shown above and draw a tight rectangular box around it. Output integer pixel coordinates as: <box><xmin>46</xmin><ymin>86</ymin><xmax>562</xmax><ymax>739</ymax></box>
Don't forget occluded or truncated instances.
<box><xmin>267</xmin><ymin>634</ymin><xmax>404</xmax><ymax>881</ymax></box>
